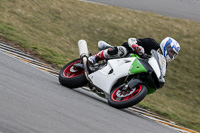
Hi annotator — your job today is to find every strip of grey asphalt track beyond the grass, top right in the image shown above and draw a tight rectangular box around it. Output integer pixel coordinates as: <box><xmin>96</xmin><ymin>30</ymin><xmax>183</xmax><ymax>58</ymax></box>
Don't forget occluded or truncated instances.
<box><xmin>83</xmin><ymin>0</ymin><xmax>200</xmax><ymax>22</ymax></box>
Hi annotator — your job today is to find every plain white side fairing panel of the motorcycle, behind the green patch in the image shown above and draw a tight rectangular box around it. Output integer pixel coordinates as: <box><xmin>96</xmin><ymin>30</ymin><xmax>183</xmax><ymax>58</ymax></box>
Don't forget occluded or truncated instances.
<box><xmin>88</xmin><ymin>57</ymin><xmax>136</xmax><ymax>94</ymax></box>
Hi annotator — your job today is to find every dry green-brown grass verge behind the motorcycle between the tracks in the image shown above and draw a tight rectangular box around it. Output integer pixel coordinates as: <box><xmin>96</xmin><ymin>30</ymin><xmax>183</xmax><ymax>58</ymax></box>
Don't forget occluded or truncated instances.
<box><xmin>0</xmin><ymin>0</ymin><xmax>200</xmax><ymax>131</ymax></box>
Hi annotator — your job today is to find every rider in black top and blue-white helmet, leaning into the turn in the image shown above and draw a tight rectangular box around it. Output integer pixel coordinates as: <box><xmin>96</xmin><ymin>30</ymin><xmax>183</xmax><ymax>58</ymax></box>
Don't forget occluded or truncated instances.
<box><xmin>89</xmin><ymin>37</ymin><xmax>180</xmax><ymax>64</ymax></box>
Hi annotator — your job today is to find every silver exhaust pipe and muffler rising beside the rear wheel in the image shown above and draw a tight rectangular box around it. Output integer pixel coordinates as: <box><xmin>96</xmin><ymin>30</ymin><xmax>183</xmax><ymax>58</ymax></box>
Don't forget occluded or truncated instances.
<box><xmin>78</xmin><ymin>40</ymin><xmax>93</xmax><ymax>86</ymax></box>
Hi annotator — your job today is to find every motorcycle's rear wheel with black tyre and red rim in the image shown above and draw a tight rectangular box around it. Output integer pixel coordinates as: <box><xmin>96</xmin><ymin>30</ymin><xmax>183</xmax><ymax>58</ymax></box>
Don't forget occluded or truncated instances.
<box><xmin>59</xmin><ymin>59</ymin><xmax>87</xmax><ymax>88</ymax></box>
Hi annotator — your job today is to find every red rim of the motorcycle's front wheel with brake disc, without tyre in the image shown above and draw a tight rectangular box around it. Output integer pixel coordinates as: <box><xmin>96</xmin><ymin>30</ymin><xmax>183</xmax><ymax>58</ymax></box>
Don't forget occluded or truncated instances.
<box><xmin>111</xmin><ymin>85</ymin><xmax>142</xmax><ymax>102</ymax></box>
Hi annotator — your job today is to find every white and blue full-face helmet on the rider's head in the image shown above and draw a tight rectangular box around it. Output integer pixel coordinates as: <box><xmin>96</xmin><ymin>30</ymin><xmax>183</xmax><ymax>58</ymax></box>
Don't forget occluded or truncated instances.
<box><xmin>160</xmin><ymin>37</ymin><xmax>180</xmax><ymax>62</ymax></box>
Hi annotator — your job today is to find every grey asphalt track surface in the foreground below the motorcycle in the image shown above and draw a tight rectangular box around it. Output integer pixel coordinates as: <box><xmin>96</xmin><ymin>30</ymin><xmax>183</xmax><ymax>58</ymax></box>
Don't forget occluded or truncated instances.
<box><xmin>0</xmin><ymin>52</ymin><xmax>180</xmax><ymax>133</ymax></box>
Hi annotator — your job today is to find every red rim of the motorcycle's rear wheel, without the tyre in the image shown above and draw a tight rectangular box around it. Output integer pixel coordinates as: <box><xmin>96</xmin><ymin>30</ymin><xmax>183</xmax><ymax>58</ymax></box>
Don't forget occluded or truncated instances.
<box><xmin>63</xmin><ymin>60</ymin><xmax>84</xmax><ymax>78</ymax></box>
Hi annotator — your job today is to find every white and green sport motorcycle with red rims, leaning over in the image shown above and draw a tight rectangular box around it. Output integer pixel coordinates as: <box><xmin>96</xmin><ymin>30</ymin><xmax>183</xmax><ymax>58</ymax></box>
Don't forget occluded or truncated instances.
<box><xmin>59</xmin><ymin>40</ymin><xmax>166</xmax><ymax>109</ymax></box>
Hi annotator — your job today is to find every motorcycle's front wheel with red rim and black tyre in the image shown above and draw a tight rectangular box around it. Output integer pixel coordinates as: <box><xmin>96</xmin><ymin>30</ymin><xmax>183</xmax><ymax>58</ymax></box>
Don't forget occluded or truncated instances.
<box><xmin>108</xmin><ymin>84</ymin><xmax>148</xmax><ymax>109</ymax></box>
